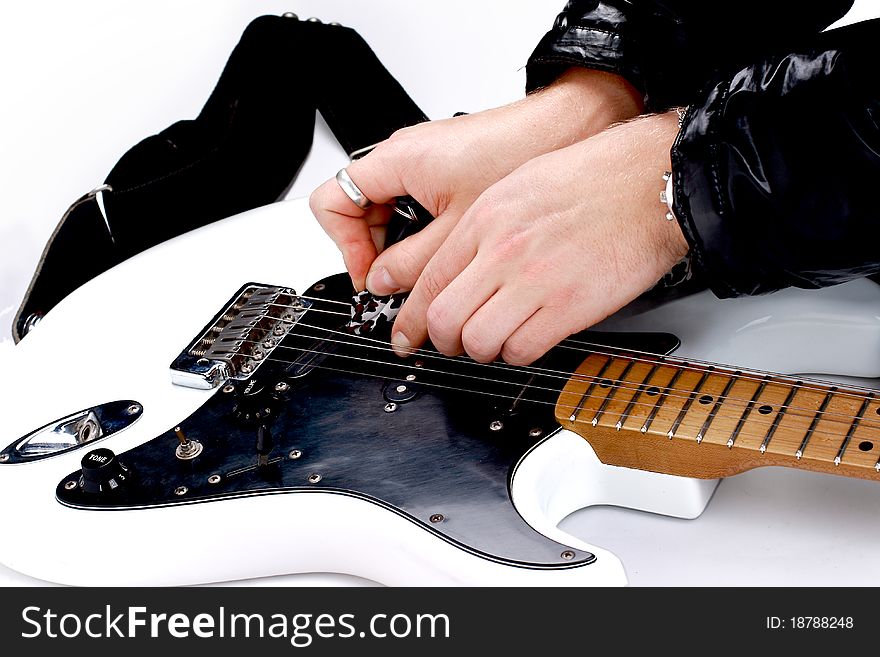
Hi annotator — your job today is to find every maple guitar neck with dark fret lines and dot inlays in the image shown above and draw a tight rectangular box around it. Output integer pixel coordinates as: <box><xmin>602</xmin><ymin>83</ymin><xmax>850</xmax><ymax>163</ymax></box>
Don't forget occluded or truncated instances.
<box><xmin>556</xmin><ymin>353</ymin><xmax>880</xmax><ymax>480</ymax></box>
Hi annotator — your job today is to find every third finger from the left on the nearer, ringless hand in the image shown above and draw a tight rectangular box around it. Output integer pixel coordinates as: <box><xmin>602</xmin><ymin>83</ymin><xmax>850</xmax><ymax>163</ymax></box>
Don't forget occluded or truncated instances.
<box><xmin>461</xmin><ymin>286</ymin><xmax>538</xmax><ymax>363</ymax></box>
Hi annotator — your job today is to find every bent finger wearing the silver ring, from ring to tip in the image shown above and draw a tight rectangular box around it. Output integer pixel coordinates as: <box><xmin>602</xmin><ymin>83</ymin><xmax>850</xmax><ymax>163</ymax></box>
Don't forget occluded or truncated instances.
<box><xmin>309</xmin><ymin>178</ymin><xmax>391</xmax><ymax>290</ymax></box>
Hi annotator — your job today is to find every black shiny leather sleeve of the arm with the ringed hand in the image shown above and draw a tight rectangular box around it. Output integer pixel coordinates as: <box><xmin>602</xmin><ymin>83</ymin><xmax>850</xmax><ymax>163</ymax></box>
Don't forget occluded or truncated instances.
<box><xmin>526</xmin><ymin>0</ymin><xmax>853</xmax><ymax>111</ymax></box>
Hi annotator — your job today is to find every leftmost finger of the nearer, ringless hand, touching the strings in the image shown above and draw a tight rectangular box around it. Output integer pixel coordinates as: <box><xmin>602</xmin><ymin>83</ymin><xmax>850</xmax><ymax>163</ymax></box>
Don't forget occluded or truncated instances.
<box><xmin>391</xmin><ymin>231</ymin><xmax>478</xmax><ymax>356</ymax></box>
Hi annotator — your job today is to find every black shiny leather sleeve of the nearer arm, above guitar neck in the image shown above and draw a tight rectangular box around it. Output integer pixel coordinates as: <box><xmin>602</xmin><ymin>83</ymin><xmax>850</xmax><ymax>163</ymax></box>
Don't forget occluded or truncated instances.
<box><xmin>672</xmin><ymin>19</ymin><xmax>880</xmax><ymax>297</ymax></box>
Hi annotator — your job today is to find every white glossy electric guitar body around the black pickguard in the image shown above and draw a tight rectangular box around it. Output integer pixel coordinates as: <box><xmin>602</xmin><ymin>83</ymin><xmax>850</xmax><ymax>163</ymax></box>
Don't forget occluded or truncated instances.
<box><xmin>0</xmin><ymin>200</ymin><xmax>880</xmax><ymax>586</ymax></box>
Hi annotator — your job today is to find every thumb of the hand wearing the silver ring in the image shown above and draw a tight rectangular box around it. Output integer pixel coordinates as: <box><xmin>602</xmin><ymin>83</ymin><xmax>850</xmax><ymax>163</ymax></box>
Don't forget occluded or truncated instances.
<box><xmin>367</xmin><ymin>212</ymin><xmax>460</xmax><ymax>295</ymax></box>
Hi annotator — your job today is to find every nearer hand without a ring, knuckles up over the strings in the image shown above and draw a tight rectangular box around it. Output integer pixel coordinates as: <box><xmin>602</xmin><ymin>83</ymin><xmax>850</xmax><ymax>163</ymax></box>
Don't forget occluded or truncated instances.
<box><xmin>391</xmin><ymin>112</ymin><xmax>688</xmax><ymax>365</ymax></box>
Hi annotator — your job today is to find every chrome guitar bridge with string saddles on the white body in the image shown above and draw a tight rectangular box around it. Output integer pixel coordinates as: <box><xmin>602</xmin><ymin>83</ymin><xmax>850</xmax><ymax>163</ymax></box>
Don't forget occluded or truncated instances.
<box><xmin>171</xmin><ymin>283</ymin><xmax>311</xmax><ymax>390</ymax></box>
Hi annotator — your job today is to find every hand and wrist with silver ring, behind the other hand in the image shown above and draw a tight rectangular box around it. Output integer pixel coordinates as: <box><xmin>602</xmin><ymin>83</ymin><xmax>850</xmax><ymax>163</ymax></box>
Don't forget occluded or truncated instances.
<box><xmin>309</xmin><ymin>69</ymin><xmax>642</xmax><ymax>294</ymax></box>
